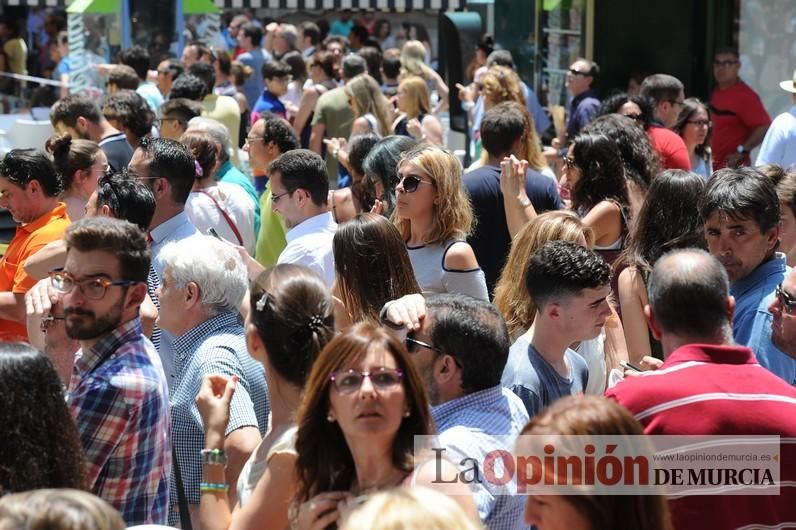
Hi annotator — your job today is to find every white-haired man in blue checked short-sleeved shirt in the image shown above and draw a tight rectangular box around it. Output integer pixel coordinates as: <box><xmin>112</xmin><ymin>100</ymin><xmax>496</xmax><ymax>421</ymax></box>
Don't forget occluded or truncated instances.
<box><xmin>156</xmin><ymin>236</ymin><xmax>269</xmax><ymax>528</ymax></box>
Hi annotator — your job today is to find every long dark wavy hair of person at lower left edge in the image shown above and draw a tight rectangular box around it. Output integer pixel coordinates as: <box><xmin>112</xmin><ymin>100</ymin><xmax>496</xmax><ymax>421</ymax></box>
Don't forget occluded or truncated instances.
<box><xmin>0</xmin><ymin>343</ymin><xmax>88</xmax><ymax>496</ymax></box>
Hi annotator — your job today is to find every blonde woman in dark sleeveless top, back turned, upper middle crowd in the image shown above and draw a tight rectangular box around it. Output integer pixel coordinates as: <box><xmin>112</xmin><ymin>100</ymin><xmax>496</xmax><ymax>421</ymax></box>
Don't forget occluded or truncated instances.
<box><xmin>393</xmin><ymin>76</ymin><xmax>443</xmax><ymax>145</ymax></box>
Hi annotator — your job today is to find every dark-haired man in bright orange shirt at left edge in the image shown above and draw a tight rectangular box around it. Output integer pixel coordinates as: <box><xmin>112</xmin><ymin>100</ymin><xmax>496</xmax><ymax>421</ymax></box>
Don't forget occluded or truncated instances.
<box><xmin>0</xmin><ymin>149</ymin><xmax>69</xmax><ymax>342</ymax></box>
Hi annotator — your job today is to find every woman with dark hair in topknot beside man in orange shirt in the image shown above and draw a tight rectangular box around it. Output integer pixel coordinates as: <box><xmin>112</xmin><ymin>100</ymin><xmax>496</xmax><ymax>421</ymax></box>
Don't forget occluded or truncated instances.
<box><xmin>45</xmin><ymin>134</ymin><xmax>109</xmax><ymax>222</ymax></box>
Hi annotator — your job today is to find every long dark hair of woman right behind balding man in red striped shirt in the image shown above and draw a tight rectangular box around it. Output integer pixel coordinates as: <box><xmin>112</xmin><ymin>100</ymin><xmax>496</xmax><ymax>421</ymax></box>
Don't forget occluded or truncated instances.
<box><xmin>624</xmin><ymin>169</ymin><xmax>707</xmax><ymax>273</ymax></box>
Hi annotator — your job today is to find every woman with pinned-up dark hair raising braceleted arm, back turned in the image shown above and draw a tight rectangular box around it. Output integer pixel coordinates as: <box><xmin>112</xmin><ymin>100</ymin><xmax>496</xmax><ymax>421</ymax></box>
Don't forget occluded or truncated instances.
<box><xmin>196</xmin><ymin>264</ymin><xmax>334</xmax><ymax>530</ymax></box>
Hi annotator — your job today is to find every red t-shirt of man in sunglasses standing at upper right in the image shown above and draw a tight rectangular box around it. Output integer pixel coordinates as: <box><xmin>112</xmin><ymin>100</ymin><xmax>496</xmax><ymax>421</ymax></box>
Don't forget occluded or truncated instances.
<box><xmin>710</xmin><ymin>81</ymin><xmax>771</xmax><ymax>170</ymax></box>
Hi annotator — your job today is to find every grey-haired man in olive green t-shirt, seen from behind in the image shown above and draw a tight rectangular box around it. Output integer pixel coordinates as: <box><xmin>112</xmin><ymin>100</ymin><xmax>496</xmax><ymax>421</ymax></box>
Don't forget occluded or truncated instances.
<box><xmin>310</xmin><ymin>54</ymin><xmax>367</xmax><ymax>182</ymax></box>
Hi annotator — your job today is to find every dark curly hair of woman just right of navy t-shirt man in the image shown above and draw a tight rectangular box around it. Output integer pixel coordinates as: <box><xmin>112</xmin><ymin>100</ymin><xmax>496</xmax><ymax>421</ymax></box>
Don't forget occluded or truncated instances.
<box><xmin>572</xmin><ymin>132</ymin><xmax>628</xmax><ymax>212</ymax></box>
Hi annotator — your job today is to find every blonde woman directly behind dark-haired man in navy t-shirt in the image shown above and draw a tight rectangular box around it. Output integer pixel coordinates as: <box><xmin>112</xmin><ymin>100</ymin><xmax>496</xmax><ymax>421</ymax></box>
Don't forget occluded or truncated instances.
<box><xmin>468</xmin><ymin>66</ymin><xmax>556</xmax><ymax>179</ymax></box>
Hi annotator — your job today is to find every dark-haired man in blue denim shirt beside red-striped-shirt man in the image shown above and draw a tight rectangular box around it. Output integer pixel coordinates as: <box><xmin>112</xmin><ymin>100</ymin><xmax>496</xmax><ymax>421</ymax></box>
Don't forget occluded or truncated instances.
<box><xmin>699</xmin><ymin>167</ymin><xmax>796</xmax><ymax>384</ymax></box>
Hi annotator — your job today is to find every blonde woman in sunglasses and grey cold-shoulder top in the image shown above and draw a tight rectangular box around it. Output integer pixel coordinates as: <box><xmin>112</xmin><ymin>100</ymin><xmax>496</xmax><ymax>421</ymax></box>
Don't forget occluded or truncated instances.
<box><xmin>392</xmin><ymin>144</ymin><xmax>489</xmax><ymax>300</ymax></box>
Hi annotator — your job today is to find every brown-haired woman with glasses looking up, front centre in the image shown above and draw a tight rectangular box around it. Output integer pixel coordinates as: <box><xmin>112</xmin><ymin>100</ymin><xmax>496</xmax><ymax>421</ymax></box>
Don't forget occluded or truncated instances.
<box><xmin>295</xmin><ymin>322</ymin><xmax>478</xmax><ymax>530</ymax></box>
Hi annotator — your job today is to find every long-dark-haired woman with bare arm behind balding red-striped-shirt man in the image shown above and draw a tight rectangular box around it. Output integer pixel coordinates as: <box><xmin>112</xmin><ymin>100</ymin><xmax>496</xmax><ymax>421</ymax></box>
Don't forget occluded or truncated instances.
<box><xmin>619</xmin><ymin>169</ymin><xmax>706</xmax><ymax>364</ymax></box>
